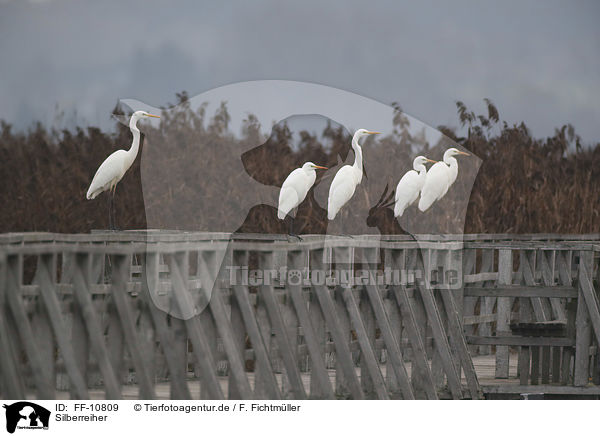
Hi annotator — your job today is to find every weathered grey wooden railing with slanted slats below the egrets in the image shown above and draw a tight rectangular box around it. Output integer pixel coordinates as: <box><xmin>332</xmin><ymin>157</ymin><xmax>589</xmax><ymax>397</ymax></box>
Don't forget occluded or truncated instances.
<box><xmin>0</xmin><ymin>231</ymin><xmax>600</xmax><ymax>399</ymax></box>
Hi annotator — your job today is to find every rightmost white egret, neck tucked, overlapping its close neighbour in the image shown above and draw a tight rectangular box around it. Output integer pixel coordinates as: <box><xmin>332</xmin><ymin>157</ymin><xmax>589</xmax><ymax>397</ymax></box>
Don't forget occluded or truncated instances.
<box><xmin>419</xmin><ymin>148</ymin><xmax>470</xmax><ymax>212</ymax></box>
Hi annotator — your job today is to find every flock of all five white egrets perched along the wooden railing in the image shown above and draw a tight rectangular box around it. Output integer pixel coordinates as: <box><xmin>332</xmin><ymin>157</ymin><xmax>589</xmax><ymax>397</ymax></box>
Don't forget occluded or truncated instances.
<box><xmin>86</xmin><ymin>111</ymin><xmax>469</xmax><ymax>235</ymax></box>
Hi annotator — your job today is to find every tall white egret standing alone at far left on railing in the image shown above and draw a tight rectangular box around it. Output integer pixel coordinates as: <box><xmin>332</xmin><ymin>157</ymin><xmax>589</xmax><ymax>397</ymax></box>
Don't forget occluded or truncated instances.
<box><xmin>86</xmin><ymin>111</ymin><xmax>160</xmax><ymax>229</ymax></box>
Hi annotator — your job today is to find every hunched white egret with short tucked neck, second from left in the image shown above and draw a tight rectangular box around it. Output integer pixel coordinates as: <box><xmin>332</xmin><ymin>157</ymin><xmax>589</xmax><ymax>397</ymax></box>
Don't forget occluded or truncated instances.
<box><xmin>277</xmin><ymin>162</ymin><xmax>327</xmax><ymax>236</ymax></box>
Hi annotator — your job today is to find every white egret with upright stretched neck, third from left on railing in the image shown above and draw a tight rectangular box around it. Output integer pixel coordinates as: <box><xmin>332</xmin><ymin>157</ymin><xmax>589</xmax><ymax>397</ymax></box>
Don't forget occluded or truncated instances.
<box><xmin>327</xmin><ymin>129</ymin><xmax>379</xmax><ymax>221</ymax></box>
